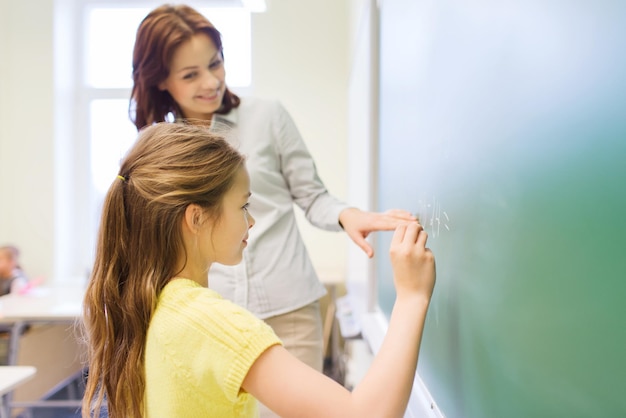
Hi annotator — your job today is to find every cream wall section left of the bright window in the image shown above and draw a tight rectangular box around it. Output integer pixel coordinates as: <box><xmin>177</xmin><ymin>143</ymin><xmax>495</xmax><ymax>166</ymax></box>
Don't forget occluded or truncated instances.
<box><xmin>0</xmin><ymin>0</ymin><xmax>54</xmax><ymax>275</ymax></box>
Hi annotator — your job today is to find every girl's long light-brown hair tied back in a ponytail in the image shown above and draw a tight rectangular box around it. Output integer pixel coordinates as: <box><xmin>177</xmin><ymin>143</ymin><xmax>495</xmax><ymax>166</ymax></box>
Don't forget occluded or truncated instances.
<box><xmin>82</xmin><ymin>123</ymin><xmax>244</xmax><ymax>418</ymax></box>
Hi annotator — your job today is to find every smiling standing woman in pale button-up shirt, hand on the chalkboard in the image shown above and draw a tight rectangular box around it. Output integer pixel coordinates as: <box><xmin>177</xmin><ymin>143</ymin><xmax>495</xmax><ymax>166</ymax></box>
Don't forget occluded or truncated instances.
<box><xmin>130</xmin><ymin>5</ymin><xmax>416</xmax><ymax>392</ymax></box>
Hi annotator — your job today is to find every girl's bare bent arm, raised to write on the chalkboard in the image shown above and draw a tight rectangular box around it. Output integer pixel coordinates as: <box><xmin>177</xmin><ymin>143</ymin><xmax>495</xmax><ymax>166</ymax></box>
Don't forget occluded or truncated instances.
<box><xmin>242</xmin><ymin>222</ymin><xmax>435</xmax><ymax>418</ymax></box>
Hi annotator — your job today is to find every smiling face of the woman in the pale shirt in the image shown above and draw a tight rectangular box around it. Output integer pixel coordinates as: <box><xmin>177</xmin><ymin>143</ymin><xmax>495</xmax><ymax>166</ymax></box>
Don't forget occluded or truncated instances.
<box><xmin>158</xmin><ymin>33</ymin><xmax>226</xmax><ymax>120</ymax></box>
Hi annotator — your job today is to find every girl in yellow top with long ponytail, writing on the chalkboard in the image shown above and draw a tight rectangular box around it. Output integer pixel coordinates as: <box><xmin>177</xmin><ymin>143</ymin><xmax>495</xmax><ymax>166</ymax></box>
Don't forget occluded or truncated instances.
<box><xmin>82</xmin><ymin>123</ymin><xmax>435</xmax><ymax>418</ymax></box>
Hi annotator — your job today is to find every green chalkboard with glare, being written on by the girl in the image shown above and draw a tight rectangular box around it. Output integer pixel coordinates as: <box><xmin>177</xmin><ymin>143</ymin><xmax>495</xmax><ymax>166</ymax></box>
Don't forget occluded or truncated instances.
<box><xmin>376</xmin><ymin>0</ymin><xmax>626</xmax><ymax>418</ymax></box>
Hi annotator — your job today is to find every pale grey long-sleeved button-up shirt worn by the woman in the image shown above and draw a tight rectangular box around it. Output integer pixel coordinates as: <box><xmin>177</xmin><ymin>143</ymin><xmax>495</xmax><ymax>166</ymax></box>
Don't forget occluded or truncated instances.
<box><xmin>209</xmin><ymin>98</ymin><xmax>348</xmax><ymax>318</ymax></box>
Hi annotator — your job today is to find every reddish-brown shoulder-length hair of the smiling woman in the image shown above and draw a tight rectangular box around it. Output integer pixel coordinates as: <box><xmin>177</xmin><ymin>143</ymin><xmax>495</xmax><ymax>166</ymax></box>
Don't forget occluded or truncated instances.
<box><xmin>129</xmin><ymin>4</ymin><xmax>240</xmax><ymax>130</ymax></box>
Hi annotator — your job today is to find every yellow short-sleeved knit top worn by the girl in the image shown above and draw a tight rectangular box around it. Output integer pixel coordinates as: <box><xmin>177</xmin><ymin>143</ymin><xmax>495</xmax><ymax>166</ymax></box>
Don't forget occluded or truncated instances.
<box><xmin>144</xmin><ymin>279</ymin><xmax>280</xmax><ymax>418</ymax></box>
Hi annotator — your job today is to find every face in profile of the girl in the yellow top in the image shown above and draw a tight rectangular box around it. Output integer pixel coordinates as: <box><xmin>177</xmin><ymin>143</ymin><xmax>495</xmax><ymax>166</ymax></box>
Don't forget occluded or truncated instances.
<box><xmin>199</xmin><ymin>167</ymin><xmax>255</xmax><ymax>265</ymax></box>
